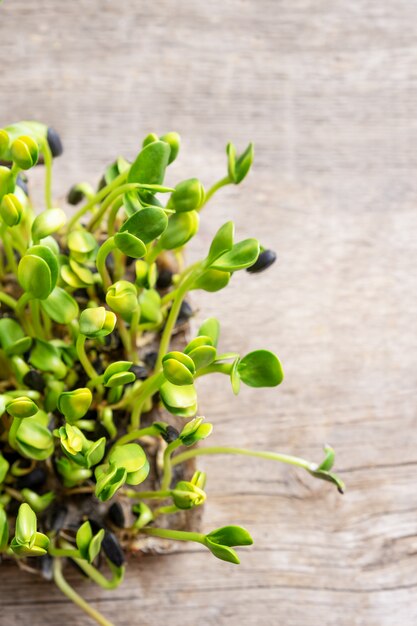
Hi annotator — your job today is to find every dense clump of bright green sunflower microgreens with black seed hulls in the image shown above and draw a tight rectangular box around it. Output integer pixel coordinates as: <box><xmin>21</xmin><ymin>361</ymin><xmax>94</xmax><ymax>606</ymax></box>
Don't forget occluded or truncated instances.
<box><xmin>0</xmin><ymin>122</ymin><xmax>344</xmax><ymax>625</ymax></box>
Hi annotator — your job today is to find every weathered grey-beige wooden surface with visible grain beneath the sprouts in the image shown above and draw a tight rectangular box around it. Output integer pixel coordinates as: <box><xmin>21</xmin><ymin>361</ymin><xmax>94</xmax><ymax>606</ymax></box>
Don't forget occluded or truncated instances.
<box><xmin>0</xmin><ymin>0</ymin><xmax>417</xmax><ymax>626</ymax></box>
